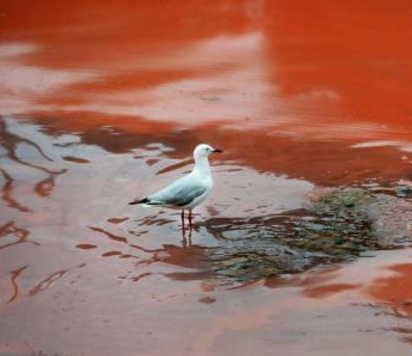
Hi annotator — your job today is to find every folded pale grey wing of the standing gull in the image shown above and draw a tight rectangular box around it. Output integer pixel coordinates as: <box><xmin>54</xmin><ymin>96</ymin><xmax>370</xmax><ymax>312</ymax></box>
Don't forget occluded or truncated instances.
<box><xmin>148</xmin><ymin>177</ymin><xmax>207</xmax><ymax>206</ymax></box>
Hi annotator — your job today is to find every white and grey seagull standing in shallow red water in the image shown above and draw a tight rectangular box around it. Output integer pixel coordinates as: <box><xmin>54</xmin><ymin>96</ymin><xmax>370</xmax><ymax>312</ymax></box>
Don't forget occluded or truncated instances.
<box><xmin>129</xmin><ymin>143</ymin><xmax>223</xmax><ymax>229</ymax></box>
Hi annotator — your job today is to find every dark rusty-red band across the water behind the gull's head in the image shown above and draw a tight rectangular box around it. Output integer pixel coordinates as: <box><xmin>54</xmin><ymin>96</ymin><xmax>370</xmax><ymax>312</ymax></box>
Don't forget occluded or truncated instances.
<box><xmin>19</xmin><ymin>117</ymin><xmax>410</xmax><ymax>191</ymax></box>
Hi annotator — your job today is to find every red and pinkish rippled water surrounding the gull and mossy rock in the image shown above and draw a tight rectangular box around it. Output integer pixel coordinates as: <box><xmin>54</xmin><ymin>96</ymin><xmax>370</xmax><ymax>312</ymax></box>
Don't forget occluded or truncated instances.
<box><xmin>0</xmin><ymin>0</ymin><xmax>412</xmax><ymax>356</ymax></box>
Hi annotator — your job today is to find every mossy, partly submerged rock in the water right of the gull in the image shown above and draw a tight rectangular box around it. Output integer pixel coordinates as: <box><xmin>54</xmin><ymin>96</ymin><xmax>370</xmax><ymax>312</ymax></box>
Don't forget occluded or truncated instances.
<box><xmin>202</xmin><ymin>188</ymin><xmax>412</xmax><ymax>283</ymax></box>
